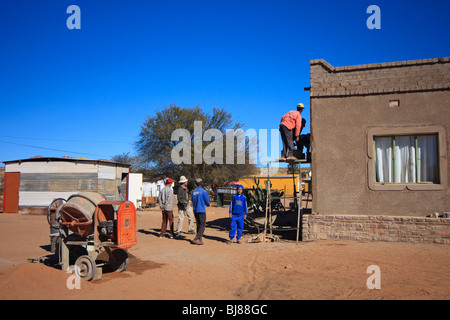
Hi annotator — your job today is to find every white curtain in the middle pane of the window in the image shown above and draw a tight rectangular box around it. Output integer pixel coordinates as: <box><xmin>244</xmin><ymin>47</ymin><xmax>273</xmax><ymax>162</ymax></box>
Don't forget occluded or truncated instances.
<box><xmin>394</xmin><ymin>136</ymin><xmax>416</xmax><ymax>183</ymax></box>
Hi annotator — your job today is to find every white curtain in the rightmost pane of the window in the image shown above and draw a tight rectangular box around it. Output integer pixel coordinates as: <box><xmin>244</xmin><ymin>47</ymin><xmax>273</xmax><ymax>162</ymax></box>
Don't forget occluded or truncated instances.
<box><xmin>417</xmin><ymin>135</ymin><xmax>439</xmax><ymax>183</ymax></box>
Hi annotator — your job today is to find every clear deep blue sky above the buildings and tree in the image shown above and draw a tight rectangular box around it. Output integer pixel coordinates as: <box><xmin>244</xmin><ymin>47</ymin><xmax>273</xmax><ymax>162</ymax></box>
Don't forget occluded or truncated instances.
<box><xmin>0</xmin><ymin>0</ymin><xmax>450</xmax><ymax>165</ymax></box>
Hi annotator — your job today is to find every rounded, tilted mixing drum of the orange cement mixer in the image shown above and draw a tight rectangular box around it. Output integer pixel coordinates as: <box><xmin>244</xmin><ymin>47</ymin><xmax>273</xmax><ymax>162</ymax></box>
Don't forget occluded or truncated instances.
<box><xmin>57</xmin><ymin>192</ymin><xmax>106</xmax><ymax>237</ymax></box>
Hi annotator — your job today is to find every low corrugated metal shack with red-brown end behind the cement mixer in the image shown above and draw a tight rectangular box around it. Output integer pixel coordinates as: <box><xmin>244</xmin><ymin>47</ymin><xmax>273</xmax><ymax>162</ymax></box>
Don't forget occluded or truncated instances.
<box><xmin>3</xmin><ymin>157</ymin><xmax>130</xmax><ymax>214</ymax></box>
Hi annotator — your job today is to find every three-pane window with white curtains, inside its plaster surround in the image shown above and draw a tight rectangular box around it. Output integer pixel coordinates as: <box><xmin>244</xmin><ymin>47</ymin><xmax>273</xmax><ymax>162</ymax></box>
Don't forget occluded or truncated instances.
<box><xmin>373</xmin><ymin>134</ymin><xmax>440</xmax><ymax>184</ymax></box>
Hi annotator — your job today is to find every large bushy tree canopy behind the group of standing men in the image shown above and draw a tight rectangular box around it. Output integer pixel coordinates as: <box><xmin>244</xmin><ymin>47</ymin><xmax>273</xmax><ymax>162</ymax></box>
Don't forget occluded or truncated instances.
<box><xmin>136</xmin><ymin>105</ymin><xmax>256</xmax><ymax>186</ymax></box>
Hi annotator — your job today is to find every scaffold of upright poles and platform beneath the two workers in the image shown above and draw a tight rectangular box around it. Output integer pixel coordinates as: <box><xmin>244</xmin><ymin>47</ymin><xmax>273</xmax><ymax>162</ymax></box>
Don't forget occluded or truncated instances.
<box><xmin>264</xmin><ymin>159</ymin><xmax>307</xmax><ymax>242</ymax></box>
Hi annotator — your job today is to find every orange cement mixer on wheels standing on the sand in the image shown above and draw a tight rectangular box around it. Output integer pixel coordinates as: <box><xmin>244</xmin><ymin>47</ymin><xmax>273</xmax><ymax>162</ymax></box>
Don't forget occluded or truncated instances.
<box><xmin>47</xmin><ymin>192</ymin><xmax>136</xmax><ymax>281</ymax></box>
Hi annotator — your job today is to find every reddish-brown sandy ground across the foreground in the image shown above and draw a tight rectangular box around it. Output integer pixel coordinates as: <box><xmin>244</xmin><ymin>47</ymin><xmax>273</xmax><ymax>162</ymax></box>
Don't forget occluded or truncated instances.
<box><xmin>0</xmin><ymin>207</ymin><xmax>450</xmax><ymax>300</ymax></box>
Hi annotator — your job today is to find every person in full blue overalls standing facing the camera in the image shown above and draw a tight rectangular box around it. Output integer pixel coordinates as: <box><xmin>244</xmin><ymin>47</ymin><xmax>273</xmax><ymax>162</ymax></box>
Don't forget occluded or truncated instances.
<box><xmin>227</xmin><ymin>185</ymin><xmax>247</xmax><ymax>244</ymax></box>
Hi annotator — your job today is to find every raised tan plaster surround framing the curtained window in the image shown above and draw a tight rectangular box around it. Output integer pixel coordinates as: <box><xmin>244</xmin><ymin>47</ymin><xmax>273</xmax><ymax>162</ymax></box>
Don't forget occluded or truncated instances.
<box><xmin>367</xmin><ymin>126</ymin><xmax>447</xmax><ymax>191</ymax></box>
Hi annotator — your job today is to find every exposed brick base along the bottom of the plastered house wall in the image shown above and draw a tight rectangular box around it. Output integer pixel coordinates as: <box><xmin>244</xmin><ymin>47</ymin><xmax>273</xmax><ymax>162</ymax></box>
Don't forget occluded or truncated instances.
<box><xmin>302</xmin><ymin>214</ymin><xmax>450</xmax><ymax>244</ymax></box>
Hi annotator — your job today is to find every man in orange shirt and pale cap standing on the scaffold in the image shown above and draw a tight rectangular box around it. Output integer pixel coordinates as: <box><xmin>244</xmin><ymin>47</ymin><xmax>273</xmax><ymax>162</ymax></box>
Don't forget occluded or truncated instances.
<box><xmin>280</xmin><ymin>103</ymin><xmax>305</xmax><ymax>159</ymax></box>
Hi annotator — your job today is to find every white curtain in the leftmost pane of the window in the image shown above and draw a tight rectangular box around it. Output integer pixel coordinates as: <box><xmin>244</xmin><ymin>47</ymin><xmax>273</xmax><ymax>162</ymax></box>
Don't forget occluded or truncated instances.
<box><xmin>375</xmin><ymin>137</ymin><xmax>394</xmax><ymax>183</ymax></box>
